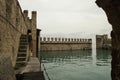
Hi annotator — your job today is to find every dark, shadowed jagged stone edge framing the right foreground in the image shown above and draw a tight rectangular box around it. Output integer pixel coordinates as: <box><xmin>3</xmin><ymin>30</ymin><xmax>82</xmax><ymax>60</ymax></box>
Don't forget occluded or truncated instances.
<box><xmin>96</xmin><ymin>0</ymin><xmax>120</xmax><ymax>80</ymax></box>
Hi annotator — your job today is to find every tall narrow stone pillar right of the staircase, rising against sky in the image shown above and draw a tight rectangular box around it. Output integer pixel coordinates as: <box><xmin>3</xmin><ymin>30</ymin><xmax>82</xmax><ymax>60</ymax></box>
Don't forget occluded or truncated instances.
<box><xmin>31</xmin><ymin>11</ymin><xmax>37</xmax><ymax>57</ymax></box>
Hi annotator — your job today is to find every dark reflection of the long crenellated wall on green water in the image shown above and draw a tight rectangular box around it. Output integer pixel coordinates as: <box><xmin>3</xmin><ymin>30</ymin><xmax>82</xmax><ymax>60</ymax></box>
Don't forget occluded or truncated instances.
<box><xmin>41</xmin><ymin>50</ymin><xmax>92</xmax><ymax>63</ymax></box>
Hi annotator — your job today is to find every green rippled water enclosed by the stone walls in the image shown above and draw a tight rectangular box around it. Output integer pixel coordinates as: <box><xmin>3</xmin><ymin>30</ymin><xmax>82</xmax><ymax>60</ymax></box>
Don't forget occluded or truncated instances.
<box><xmin>41</xmin><ymin>50</ymin><xmax>111</xmax><ymax>80</ymax></box>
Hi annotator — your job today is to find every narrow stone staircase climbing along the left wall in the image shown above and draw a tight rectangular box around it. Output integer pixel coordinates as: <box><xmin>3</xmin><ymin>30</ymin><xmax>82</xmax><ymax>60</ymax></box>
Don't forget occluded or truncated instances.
<box><xmin>16</xmin><ymin>35</ymin><xmax>28</xmax><ymax>68</ymax></box>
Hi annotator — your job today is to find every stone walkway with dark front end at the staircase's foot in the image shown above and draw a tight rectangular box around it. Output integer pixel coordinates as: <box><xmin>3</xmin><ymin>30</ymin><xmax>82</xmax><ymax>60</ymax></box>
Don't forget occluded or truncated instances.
<box><xmin>16</xmin><ymin>57</ymin><xmax>45</xmax><ymax>80</ymax></box>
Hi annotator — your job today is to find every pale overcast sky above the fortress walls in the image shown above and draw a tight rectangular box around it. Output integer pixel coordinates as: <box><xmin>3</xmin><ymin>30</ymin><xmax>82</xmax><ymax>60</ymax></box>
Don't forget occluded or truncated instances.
<box><xmin>19</xmin><ymin>0</ymin><xmax>111</xmax><ymax>34</ymax></box>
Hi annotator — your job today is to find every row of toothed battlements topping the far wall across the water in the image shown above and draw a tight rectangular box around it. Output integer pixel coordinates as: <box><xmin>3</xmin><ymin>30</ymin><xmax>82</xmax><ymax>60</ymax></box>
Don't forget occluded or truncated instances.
<box><xmin>40</xmin><ymin>37</ymin><xmax>92</xmax><ymax>44</ymax></box>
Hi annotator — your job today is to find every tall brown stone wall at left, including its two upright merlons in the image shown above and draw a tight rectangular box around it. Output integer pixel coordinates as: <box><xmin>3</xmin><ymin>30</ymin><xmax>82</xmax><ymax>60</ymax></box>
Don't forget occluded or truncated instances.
<box><xmin>0</xmin><ymin>0</ymin><xmax>36</xmax><ymax>80</ymax></box>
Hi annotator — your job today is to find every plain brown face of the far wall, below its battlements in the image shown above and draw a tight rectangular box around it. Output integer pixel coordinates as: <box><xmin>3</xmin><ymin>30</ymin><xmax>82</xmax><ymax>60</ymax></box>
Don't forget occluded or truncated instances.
<box><xmin>41</xmin><ymin>43</ymin><xmax>91</xmax><ymax>51</ymax></box>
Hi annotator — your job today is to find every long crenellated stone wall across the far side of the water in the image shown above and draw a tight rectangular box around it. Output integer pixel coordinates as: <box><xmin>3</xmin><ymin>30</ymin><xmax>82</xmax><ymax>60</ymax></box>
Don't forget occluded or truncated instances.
<box><xmin>40</xmin><ymin>37</ymin><xmax>92</xmax><ymax>51</ymax></box>
